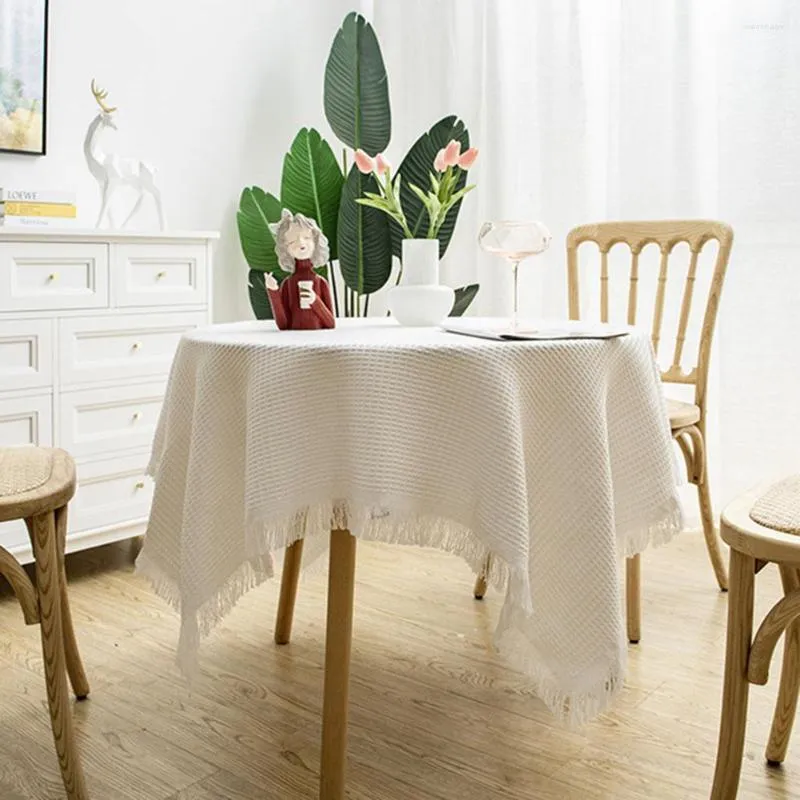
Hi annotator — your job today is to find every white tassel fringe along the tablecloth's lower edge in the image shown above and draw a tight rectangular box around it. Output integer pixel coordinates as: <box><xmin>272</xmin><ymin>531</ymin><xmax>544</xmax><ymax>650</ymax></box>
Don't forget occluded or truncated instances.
<box><xmin>136</xmin><ymin>494</ymin><xmax>682</xmax><ymax>726</ymax></box>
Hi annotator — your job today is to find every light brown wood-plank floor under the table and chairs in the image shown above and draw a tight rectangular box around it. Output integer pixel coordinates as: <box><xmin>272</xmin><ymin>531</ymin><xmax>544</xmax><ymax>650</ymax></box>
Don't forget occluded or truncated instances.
<box><xmin>0</xmin><ymin>534</ymin><xmax>800</xmax><ymax>800</ymax></box>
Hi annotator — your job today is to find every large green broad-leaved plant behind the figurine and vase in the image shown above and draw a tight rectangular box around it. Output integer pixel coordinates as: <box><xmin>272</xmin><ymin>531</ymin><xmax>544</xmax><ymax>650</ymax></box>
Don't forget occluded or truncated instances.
<box><xmin>237</xmin><ymin>12</ymin><xmax>478</xmax><ymax>319</ymax></box>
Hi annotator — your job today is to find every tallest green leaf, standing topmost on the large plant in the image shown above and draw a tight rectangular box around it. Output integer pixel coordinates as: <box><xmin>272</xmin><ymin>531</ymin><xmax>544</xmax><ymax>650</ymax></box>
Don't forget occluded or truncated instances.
<box><xmin>324</xmin><ymin>12</ymin><xmax>392</xmax><ymax>156</ymax></box>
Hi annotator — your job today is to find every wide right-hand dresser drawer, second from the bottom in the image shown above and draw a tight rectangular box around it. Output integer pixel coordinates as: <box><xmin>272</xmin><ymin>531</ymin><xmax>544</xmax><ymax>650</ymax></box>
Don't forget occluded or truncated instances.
<box><xmin>59</xmin><ymin>382</ymin><xmax>165</xmax><ymax>457</ymax></box>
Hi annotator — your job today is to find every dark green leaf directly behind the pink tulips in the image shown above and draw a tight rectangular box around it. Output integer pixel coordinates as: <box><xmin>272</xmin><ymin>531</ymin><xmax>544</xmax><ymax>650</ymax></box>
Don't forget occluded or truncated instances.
<box><xmin>391</xmin><ymin>116</ymin><xmax>469</xmax><ymax>258</ymax></box>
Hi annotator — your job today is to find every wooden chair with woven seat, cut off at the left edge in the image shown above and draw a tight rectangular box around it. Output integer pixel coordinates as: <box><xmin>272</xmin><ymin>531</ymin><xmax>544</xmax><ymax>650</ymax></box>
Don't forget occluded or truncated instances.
<box><xmin>0</xmin><ymin>447</ymin><xmax>89</xmax><ymax>800</ymax></box>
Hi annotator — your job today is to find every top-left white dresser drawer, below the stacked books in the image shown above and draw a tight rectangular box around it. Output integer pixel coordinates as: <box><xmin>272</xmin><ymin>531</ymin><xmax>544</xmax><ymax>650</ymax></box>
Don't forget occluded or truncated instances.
<box><xmin>0</xmin><ymin>242</ymin><xmax>108</xmax><ymax>311</ymax></box>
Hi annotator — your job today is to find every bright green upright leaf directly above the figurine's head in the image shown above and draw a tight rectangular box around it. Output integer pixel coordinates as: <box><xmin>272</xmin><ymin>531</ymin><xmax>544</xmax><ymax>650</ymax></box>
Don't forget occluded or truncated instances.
<box><xmin>281</xmin><ymin>128</ymin><xmax>344</xmax><ymax>259</ymax></box>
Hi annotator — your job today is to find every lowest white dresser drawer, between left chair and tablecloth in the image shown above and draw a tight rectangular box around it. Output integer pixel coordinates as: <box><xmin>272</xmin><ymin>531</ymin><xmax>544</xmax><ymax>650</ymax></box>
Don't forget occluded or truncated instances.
<box><xmin>69</xmin><ymin>453</ymin><xmax>153</xmax><ymax>533</ymax></box>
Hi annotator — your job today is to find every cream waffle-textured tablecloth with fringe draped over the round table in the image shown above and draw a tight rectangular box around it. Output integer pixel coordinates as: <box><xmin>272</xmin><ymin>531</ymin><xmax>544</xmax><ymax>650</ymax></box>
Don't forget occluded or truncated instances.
<box><xmin>138</xmin><ymin>320</ymin><xmax>681</xmax><ymax>722</ymax></box>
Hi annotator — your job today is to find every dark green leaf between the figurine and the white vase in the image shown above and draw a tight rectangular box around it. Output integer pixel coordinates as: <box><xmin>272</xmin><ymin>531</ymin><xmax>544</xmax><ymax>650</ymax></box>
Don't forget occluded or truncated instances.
<box><xmin>339</xmin><ymin>164</ymin><xmax>392</xmax><ymax>294</ymax></box>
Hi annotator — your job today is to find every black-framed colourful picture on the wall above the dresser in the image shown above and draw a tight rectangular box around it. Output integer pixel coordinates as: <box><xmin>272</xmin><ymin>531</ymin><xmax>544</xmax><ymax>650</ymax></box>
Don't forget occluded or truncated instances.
<box><xmin>0</xmin><ymin>0</ymin><xmax>48</xmax><ymax>156</ymax></box>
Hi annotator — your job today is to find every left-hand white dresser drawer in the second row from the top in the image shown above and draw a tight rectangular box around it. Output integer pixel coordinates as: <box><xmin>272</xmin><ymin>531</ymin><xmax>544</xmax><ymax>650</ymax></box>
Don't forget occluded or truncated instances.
<box><xmin>0</xmin><ymin>319</ymin><xmax>53</xmax><ymax>390</ymax></box>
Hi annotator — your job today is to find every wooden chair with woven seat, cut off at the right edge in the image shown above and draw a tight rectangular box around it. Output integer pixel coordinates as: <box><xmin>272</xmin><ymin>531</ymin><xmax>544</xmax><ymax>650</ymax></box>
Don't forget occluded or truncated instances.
<box><xmin>711</xmin><ymin>476</ymin><xmax>800</xmax><ymax>800</ymax></box>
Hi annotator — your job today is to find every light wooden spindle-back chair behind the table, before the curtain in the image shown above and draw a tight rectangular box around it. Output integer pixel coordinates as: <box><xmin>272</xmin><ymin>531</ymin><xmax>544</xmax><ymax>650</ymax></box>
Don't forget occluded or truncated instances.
<box><xmin>474</xmin><ymin>220</ymin><xmax>733</xmax><ymax>643</ymax></box>
